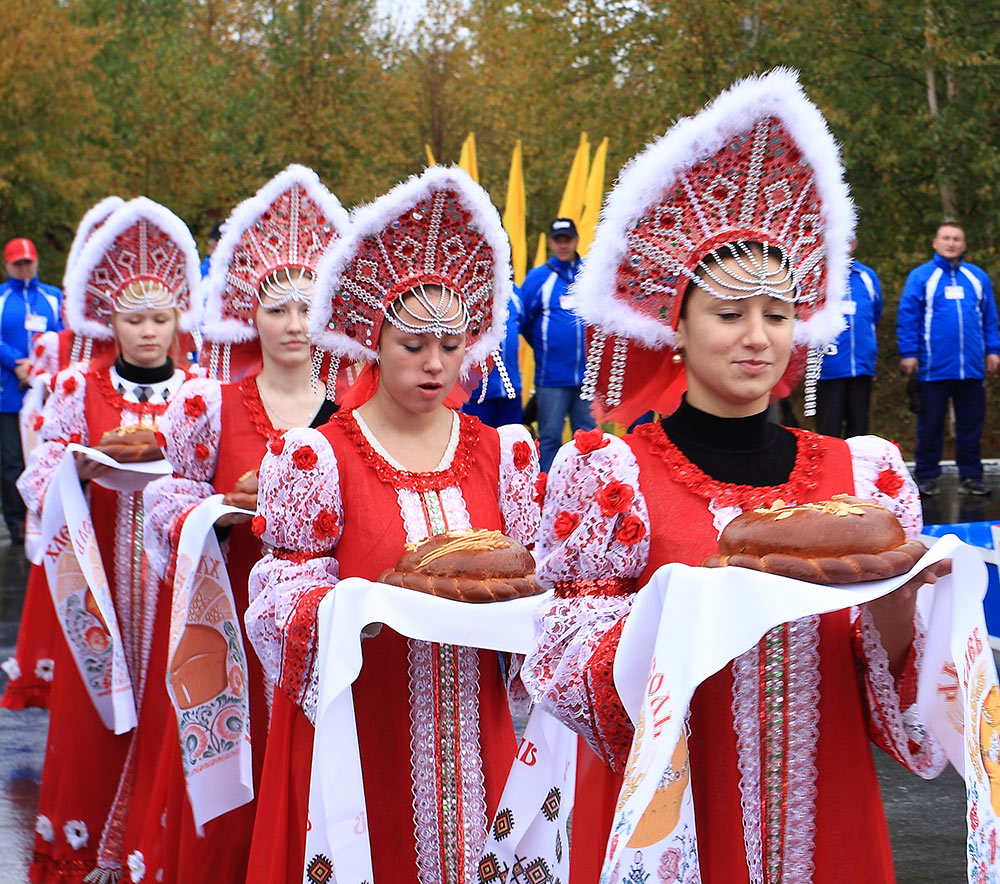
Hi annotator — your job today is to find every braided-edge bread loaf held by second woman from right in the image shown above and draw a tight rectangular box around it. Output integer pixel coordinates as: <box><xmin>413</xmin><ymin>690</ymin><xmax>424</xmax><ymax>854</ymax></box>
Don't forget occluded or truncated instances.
<box><xmin>379</xmin><ymin>530</ymin><xmax>544</xmax><ymax>602</ymax></box>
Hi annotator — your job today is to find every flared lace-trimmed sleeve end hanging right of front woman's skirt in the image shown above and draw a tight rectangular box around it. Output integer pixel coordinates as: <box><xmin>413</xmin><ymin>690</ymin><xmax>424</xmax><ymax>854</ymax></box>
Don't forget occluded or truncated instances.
<box><xmin>852</xmin><ymin>608</ymin><xmax>947</xmax><ymax>780</ymax></box>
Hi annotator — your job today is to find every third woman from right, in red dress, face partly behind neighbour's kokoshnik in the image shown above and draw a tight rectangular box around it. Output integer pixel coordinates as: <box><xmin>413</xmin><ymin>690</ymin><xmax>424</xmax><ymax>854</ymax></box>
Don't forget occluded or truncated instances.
<box><xmin>117</xmin><ymin>165</ymin><xmax>348</xmax><ymax>884</ymax></box>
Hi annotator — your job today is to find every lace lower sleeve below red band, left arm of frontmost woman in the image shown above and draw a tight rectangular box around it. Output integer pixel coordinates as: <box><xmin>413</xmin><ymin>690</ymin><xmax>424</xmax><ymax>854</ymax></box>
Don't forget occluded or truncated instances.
<box><xmin>521</xmin><ymin>596</ymin><xmax>632</xmax><ymax>765</ymax></box>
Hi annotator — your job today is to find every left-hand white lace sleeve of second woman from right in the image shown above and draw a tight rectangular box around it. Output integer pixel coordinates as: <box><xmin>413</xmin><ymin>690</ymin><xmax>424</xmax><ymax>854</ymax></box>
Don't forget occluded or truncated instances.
<box><xmin>245</xmin><ymin>429</ymin><xmax>344</xmax><ymax>693</ymax></box>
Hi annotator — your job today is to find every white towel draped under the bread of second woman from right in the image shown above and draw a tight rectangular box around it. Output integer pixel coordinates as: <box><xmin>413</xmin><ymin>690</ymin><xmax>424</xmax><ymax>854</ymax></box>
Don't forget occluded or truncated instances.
<box><xmin>303</xmin><ymin>577</ymin><xmax>550</xmax><ymax>884</ymax></box>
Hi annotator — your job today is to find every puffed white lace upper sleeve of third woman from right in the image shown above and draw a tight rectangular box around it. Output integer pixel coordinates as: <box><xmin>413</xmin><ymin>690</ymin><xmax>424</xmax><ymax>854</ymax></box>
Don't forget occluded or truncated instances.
<box><xmin>159</xmin><ymin>378</ymin><xmax>222</xmax><ymax>480</ymax></box>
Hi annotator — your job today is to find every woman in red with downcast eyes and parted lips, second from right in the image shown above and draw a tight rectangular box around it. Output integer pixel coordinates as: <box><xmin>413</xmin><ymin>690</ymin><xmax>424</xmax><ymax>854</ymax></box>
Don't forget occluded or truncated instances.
<box><xmin>247</xmin><ymin>167</ymin><xmax>538</xmax><ymax>884</ymax></box>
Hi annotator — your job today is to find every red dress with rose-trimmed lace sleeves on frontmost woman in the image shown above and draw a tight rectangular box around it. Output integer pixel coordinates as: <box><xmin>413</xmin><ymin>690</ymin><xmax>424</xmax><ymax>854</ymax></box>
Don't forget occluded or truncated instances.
<box><xmin>523</xmin><ymin>415</ymin><xmax>944</xmax><ymax>884</ymax></box>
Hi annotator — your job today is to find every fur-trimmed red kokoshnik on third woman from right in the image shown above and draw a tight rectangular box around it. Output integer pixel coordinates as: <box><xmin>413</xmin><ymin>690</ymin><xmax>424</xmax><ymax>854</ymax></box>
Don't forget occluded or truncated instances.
<box><xmin>202</xmin><ymin>164</ymin><xmax>350</xmax><ymax>344</ymax></box>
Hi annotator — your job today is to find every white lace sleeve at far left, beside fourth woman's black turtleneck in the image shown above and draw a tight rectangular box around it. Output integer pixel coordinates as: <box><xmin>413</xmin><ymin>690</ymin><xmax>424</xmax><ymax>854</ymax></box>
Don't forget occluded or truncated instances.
<box><xmin>17</xmin><ymin>367</ymin><xmax>90</xmax><ymax>516</ymax></box>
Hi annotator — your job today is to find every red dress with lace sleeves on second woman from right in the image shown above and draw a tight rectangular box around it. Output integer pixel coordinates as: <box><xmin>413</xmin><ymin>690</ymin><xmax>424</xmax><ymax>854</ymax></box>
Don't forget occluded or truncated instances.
<box><xmin>247</xmin><ymin>411</ymin><xmax>538</xmax><ymax>884</ymax></box>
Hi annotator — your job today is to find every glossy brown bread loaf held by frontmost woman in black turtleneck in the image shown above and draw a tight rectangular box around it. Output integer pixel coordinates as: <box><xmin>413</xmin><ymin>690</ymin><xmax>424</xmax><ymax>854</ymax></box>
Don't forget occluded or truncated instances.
<box><xmin>704</xmin><ymin>494</ymin><xmax>926</xmax><ymax>584</ymax></box>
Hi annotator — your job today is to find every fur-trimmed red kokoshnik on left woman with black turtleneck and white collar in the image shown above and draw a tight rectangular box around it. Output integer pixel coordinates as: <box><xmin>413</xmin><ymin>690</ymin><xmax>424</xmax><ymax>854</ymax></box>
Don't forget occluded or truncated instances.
<box><xmin>63</xmin><ymin>196</ymin><xmax>201</xmax><ymax>341</ymax></box>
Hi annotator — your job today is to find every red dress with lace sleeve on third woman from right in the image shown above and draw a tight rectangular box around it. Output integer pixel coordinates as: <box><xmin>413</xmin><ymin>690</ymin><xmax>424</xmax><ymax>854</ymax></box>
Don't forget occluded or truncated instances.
<box><xmin>125</xmin><ymin>374</ymin><xmax>334</xmax><ymax>884</ymax></box>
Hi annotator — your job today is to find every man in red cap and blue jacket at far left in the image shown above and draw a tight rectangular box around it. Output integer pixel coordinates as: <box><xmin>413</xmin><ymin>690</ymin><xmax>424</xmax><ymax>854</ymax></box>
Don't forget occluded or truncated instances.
<box><xmin>0</xmin><ymin>237</ymin><xmax>62</xmax><ymax>544</ymax></box>
